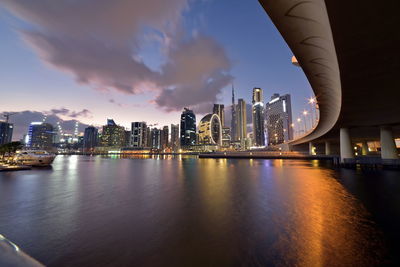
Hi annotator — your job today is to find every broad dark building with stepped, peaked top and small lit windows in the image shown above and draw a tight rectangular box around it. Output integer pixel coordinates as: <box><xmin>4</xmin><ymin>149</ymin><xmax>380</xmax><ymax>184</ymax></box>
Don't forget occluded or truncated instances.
<box><xmin>101</xmin><ymin>119</ymin><xmax>126</xmax><ymax>147</ymax></box>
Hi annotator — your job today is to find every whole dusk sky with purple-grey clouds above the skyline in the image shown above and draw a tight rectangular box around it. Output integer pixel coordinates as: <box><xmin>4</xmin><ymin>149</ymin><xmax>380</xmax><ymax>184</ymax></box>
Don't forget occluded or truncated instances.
<box><xmin>0</xmin><ymin>0</ymin><xmax>312</xmax><ymax>139</ymax></box>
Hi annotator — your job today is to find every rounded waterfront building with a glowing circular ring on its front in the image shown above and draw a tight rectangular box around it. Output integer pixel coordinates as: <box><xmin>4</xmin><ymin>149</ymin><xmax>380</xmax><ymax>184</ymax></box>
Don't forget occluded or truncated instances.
<box><xmin>199</xmin><ymin>114</ymin><xmax>222</xmax><ymax>146</ymax></box>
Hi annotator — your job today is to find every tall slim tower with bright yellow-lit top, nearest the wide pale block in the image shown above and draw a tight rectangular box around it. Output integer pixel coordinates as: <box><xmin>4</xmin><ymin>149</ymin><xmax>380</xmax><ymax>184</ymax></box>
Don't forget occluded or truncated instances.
<box><xmin>252</xmin><ymin>88</ymin><xmax>265</xmax><ymax>146</ymax></box>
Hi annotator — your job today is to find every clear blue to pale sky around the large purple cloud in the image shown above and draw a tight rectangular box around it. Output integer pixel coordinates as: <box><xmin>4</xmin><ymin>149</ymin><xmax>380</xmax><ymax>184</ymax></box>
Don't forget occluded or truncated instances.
<box><xmin>0</xmin><ymin>1</ymin><xmax>312</xmax><ymax>139</ymax></box>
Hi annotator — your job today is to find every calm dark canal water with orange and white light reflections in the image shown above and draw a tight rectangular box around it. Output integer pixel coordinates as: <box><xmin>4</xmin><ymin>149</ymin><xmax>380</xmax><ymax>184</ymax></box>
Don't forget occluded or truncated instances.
<box><xmin>0</xmin><ymin>156</ymin><xmax>400</xmax><ymax>267</ymax></box>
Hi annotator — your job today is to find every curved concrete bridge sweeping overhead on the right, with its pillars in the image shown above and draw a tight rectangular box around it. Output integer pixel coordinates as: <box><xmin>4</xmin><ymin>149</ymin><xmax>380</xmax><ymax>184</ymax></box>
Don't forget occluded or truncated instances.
<box><xmin>259</xmin><ymin>0</ymin><xmax>400</xmax><ymax>163</ymax></box>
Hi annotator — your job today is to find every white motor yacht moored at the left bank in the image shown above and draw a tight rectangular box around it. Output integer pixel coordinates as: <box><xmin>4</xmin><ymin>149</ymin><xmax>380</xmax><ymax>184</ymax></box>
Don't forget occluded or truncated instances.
<box><xmin>14</xmin><ymin>150</ymin><xmax>56</xmax><ymax>166</ymax></box>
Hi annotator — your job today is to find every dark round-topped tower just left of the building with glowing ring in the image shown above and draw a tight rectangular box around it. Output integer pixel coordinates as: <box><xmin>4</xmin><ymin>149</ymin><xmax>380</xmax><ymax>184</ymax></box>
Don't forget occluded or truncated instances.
<box><xmin>181</xmin><ymin>108</ymin><xmax>196</xmax><ymax>148</ymax></box>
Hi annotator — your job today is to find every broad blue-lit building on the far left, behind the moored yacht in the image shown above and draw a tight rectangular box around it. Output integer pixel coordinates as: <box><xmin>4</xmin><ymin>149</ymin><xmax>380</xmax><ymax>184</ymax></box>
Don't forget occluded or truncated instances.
<box><xmin>28</xmin><ymin>122</ymin><xmax>54</xmax><ymax>150</ymax></box>
